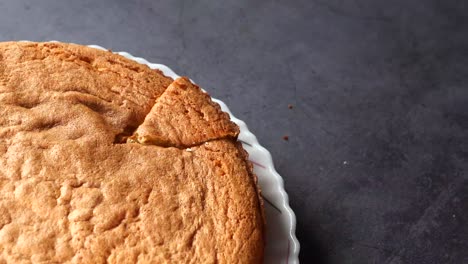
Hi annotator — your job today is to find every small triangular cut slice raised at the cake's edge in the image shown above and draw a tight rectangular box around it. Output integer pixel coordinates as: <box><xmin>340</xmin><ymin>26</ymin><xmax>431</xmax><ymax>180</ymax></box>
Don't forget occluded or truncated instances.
<box><xmin>130</xmin><ymin>78</ymin><xmax>239</xmax><ymax>147</ymax></box>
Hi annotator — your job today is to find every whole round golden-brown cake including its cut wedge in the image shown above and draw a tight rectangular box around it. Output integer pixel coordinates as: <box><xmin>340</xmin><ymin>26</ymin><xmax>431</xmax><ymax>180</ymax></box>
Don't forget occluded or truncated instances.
<box><xmin>0</xmin><ymin>42</ymin><xmax>264</xmax><ymax>263</ymax></box>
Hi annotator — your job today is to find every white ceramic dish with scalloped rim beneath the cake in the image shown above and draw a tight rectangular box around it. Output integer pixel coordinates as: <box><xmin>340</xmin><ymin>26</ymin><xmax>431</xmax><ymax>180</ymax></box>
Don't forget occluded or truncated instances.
<box><xmin>82</xmin><ymin>45</ymin><xmax>299</xmax><ymax>264</ymax></box>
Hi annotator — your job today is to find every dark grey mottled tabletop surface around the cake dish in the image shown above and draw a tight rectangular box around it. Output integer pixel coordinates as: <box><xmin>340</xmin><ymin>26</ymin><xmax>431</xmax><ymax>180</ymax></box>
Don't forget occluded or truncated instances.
<box><xmin>0</xmin><ymin>0</ymin><xmax>468</xmax><ymax>264</ymax></box>
